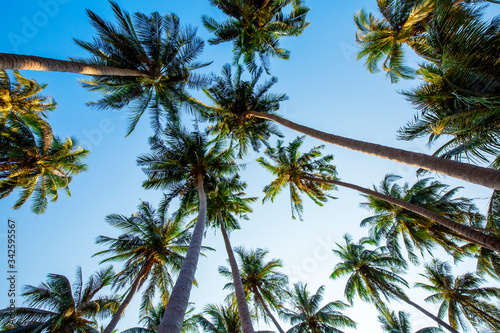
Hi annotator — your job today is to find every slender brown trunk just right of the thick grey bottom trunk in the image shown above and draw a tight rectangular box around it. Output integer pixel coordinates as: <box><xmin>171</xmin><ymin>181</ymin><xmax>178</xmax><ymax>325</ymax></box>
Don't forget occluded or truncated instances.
<box><xmin>218</xmin><ymin>209</ymin><xmax>254</xmax><ymax>333</ymax></box>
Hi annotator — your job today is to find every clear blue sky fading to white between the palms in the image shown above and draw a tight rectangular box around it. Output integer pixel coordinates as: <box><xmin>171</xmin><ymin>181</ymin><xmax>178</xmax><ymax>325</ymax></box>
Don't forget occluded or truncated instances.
<box><xmin>0</xmin><ymin>0</ymin><xmax>498</xmax><ymax>332</ymax></box>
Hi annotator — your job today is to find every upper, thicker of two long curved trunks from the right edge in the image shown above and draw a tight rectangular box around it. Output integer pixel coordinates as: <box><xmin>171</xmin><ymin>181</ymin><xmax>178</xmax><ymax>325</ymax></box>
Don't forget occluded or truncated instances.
<box><xmin>247</xmin><ymin>111</ymin><xmax>500</xmax><ymax>189</ymax></box>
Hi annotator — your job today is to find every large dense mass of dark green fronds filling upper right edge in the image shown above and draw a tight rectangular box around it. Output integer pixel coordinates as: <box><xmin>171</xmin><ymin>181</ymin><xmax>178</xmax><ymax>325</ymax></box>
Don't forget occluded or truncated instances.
<box><xmin>398</xmin><ymin>1</ymin><xmax>500</xmax><ymax>169</ymax></box>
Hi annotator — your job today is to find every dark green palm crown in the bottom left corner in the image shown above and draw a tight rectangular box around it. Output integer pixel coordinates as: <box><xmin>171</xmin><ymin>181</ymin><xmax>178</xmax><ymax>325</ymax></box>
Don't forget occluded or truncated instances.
<box><xmin>0</xmin><ymin>267</ymin><xmax>119</xmax><ymax>333</ymax></box>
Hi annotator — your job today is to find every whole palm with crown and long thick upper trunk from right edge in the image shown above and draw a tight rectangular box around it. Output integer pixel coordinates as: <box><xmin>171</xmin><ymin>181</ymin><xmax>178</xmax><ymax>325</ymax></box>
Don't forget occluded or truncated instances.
<box><xmin>198</xmin><ymin>66</ymin><xmax>500</xmax><ymax>189</ymax></box>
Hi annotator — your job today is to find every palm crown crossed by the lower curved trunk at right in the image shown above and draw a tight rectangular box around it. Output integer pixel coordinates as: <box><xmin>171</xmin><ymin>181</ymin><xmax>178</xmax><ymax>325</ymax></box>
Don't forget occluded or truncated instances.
<box><xmin>361</xmin><ymin>174</ymin><xmax>484</xmax><ymax>263</ymax></box>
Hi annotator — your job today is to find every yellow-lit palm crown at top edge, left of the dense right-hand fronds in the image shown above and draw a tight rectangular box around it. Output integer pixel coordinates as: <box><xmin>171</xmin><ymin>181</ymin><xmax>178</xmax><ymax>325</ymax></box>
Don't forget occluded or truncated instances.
<box><xmin>354</xmin><ymin>0</ymin><xmax>435</xmax><ymax>83</ymax></box>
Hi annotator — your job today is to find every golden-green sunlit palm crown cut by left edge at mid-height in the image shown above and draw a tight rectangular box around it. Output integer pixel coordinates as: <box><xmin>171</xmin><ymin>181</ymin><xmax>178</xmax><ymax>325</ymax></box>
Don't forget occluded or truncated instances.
<box><xmin>0</xmin><ymin>119</ymin><xmax>89</xmax><ymax>214</ymax></box>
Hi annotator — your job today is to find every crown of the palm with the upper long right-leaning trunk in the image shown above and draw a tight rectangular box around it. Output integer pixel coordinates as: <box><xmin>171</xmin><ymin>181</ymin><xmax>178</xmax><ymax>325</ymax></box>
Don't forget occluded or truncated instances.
<box><xmin>202</xmin><ymin>64</ymin><xmax>288</xmax><ymax>157</ymax></box>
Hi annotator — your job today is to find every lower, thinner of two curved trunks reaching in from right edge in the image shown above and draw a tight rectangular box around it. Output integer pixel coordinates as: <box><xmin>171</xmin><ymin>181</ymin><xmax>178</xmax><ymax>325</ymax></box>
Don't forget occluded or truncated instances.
<box><xmin>304</xmin><ymin>177</ymin><xmax>500</xmax><ymax>253</ymax></box>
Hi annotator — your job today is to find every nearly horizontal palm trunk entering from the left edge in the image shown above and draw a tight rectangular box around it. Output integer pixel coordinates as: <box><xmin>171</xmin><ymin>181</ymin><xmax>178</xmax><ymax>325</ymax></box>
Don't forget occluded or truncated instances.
<box><xmin>0</xmin><ymin>53</ymin><xmax>150</xmax><ymax>77</ymax></box>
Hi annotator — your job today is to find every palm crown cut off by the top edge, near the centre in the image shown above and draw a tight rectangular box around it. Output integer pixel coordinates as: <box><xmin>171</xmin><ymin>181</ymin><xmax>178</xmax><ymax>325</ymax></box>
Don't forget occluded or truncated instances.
<box><xmin>202</xmin><ymin>0</ymin><xmax>309</xmax><ymax>72</ymax></box>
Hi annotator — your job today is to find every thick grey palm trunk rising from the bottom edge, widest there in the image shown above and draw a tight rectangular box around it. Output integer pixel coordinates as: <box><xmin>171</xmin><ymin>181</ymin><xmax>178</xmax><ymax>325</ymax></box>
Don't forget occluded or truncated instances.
<box><xmin>158</xmin><ymin>174</ymin><xmax>207</xmax><ymax>333</ymax></box>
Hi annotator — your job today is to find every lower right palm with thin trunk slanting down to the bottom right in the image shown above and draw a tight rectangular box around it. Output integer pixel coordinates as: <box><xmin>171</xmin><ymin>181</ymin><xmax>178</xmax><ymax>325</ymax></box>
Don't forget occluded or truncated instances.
<box><xmin>330</xmin><ymin>235</ymin><xmax>458</xmax><ymax>333</ymax></box>
